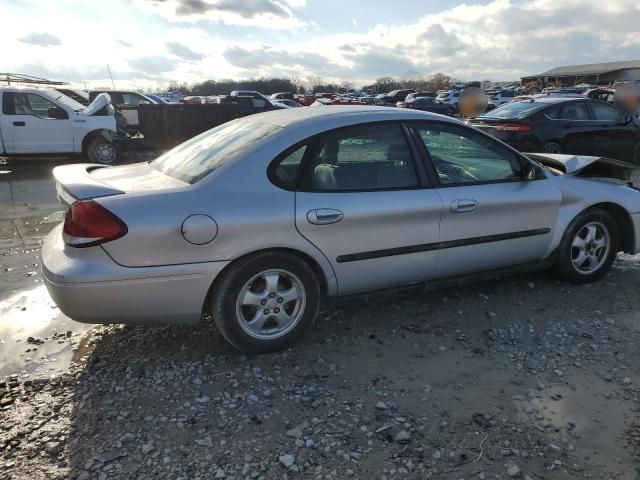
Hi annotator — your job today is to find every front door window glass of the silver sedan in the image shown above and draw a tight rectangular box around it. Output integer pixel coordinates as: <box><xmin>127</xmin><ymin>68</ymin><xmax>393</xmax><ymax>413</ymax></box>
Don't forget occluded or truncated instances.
<box><xmin>414</xmin><ymin>123</ymin><xmax>522</xmax><ymax>185</ymax></box>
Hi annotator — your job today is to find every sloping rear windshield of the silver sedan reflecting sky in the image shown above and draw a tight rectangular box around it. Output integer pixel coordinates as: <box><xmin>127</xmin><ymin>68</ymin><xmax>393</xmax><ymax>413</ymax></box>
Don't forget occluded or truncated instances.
<box><xmin>150</xmin><ymin>119</ymin><xmax>280</xmax><ymax>184</ymax></box>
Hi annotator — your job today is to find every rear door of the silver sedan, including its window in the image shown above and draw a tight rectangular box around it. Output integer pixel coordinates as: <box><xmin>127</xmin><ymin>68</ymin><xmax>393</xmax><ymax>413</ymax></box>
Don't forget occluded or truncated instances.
<box><xmin>295</xmin><ymin>122</ymin><xmax>442</xmax><ymax>295</ymax></box>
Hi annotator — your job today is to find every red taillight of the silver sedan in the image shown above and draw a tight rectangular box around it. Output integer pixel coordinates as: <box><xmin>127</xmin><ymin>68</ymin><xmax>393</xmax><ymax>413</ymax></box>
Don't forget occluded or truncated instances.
<box><xmin>62</xmin><ymin>200</ymin><xmax>127</xmax><ymax>247</ymax></box>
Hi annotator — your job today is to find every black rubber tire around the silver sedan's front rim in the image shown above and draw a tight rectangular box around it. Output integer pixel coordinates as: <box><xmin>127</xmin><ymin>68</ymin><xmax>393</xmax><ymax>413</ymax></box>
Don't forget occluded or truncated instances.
<box><xmin>552</xmin><ymin>209</ymin><xmax>620</xmax><ymax>283</ymax></box>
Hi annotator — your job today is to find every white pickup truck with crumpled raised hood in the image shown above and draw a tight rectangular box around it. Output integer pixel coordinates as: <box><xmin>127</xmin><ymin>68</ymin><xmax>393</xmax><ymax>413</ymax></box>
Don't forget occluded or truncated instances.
<box><xmin>0</xmin><ymin>86</ymin><xmax>117</xmax><ymax>164</ymax></box>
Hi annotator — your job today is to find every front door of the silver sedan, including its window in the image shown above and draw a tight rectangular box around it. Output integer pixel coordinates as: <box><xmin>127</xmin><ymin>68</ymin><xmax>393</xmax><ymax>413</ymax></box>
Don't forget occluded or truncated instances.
<box><xmin>412</xmin><ymin>122</ymin><xmax>561</xmax><ymax>278</ymax></box>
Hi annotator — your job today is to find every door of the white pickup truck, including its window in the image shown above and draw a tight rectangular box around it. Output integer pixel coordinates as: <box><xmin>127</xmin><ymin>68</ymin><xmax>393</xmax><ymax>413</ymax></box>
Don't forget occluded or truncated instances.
<box><xmin>2</xmin><ymin>92</ymin><xmax>73</xmax><ymax>154</ymax></box>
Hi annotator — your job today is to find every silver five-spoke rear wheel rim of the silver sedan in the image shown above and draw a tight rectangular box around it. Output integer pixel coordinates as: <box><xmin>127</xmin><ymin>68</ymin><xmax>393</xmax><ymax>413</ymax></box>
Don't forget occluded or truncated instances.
<box><xmin>236</xmin><ymin>269</ymin><xmax>306</xmax><ymax>340</ymax></box>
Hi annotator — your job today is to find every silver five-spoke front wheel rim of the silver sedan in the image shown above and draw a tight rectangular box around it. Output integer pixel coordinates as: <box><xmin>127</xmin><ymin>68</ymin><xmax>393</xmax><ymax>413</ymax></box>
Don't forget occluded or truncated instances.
<box><xmin>571</xmin><ymin>222</ymin><xmax>611</xmax><ymax>275</ymax></box>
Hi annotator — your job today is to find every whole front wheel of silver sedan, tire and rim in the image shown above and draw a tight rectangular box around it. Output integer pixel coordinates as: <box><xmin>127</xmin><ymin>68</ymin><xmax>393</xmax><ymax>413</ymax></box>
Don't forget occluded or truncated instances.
<box><xmin>553</xmin><ymin>209</ymin><xmax>620</xmax><ymax>283</ymax></box>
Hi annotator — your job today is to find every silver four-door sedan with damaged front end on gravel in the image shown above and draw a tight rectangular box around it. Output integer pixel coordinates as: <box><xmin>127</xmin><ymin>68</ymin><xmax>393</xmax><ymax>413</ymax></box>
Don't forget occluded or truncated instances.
<box><xmin>42</xmin><ymin>106</ymin><xmax>640</xmax><ymax>353</ymax></box>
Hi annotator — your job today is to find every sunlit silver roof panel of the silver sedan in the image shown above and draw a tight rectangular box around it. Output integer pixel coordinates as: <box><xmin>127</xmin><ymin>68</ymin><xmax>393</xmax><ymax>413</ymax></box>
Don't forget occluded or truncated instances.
<box><xmin>252</xmin><ymin>105</ymin><xmax>455</xmax><ymax>128</ymax></box>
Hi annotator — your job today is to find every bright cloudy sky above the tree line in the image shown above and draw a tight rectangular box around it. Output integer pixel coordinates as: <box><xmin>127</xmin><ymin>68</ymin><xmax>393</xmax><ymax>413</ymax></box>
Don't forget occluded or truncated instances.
<box><xmin>0</xmin><ymin>0</ymin><xmax>640</xmax><ymax>91</ymax></box>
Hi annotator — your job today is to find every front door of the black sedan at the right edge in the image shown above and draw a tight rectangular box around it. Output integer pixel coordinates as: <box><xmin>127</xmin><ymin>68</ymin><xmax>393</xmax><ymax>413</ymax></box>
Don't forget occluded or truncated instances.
<box><xmin>589</xmin><ymin>101</ymin><xmax>637</xmax><ymax>161</ymax></box>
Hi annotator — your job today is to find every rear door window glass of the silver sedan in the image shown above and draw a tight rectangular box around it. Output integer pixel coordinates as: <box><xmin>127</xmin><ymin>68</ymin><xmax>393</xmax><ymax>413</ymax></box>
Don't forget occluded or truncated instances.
<box><xmin>308</xmin><ymin>123</ymin><xmax>418</xmax><ymax>191</ymax></box>
